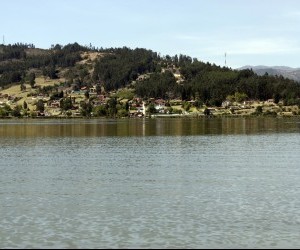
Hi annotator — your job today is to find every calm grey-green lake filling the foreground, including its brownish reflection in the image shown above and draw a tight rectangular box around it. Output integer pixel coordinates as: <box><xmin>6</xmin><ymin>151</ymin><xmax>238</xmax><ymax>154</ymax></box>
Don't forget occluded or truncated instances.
<box><xmin>0</xmin><ymin>118</ymin><xmax>300</xmax><ymax>248</ymax></box>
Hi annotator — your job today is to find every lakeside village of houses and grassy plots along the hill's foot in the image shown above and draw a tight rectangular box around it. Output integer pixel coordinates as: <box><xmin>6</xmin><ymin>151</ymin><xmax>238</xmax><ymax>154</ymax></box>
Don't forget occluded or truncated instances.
<box><xmin>0</xmin><ymin>75</ymin><xmax>300</xmax><ymax>118</ymax></box>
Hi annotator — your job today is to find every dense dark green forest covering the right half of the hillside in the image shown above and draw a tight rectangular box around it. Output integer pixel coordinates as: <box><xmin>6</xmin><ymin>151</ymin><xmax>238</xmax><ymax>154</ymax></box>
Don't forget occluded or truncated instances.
<box><xmin>136</xmin><ymin>60</ymin><xmax>300</xmax><ymax>106</ymax></box>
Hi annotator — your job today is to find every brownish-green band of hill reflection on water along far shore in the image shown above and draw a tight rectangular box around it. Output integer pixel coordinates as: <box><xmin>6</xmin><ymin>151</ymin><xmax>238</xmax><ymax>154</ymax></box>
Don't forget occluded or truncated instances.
<box><xmin>0</xmin><ymin>118</ymin><xmax>300</xmax><ymax>137</ymax></box>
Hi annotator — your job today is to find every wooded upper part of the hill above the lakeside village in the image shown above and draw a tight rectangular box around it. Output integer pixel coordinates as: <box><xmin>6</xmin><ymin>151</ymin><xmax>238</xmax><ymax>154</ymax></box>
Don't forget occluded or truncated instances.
<box><xmin>0</xmin><ymin>43</ymin><xmax>300</xmax><ymax>106</ymax></box>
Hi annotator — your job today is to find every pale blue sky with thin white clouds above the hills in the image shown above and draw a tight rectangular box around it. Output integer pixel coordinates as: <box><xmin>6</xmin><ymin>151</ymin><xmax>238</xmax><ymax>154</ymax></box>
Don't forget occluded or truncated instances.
<box><xmin>0</xmin><ymin>0</ymin><xmax>300</xmax><ymax>68</ymax></box>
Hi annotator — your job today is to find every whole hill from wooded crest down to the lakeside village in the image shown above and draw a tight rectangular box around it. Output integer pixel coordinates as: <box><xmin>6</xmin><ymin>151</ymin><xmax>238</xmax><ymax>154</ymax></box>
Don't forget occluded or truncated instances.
<box><xmin>0</xmin><ymin>43</ymin><xmax>300</xmax><ymax>117</ymax></box>
